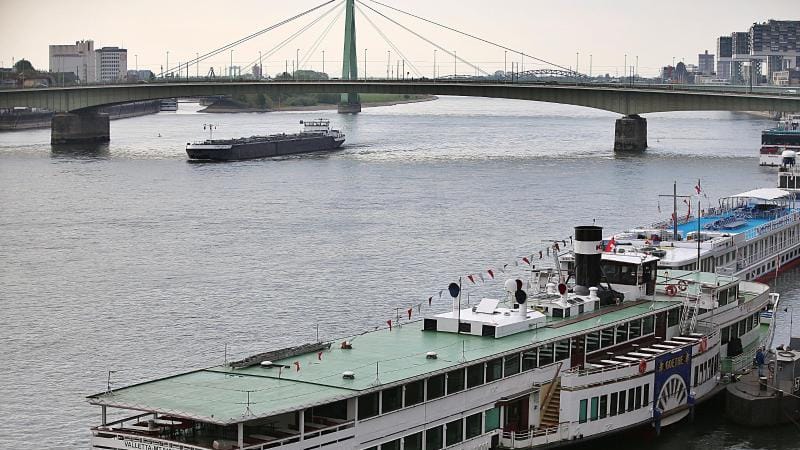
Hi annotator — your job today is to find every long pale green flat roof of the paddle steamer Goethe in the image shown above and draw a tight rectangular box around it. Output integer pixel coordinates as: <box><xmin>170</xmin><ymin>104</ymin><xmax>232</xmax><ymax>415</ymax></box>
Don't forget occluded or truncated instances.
<box><xmin>89</xmin><ymin>296</ymin><xmax>677</xmax><ymax>424</ymax></box>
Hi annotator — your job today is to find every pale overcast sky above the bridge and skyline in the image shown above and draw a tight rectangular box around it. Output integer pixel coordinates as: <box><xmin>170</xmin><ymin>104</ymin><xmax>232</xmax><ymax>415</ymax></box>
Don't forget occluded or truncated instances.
<box><xmin>0</xmin><ymin>0</ymin><xmax>800</xmax><ymax>76</ymax></box>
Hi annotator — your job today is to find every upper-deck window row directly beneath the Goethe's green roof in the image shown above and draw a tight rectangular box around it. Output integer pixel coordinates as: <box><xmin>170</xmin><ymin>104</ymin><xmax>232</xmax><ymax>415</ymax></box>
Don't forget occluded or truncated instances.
<box><xmin>358</xmin><ymin>308</ymin><xmax>668</xmax><ymax>420</ymax></box>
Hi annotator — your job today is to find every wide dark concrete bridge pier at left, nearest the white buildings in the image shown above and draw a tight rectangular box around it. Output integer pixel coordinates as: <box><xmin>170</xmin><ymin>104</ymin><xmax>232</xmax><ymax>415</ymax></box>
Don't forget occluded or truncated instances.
<box><xmin>50</xmin><ymin>109</ymin><xmax>111</xmax><ymax>144</ymax></box>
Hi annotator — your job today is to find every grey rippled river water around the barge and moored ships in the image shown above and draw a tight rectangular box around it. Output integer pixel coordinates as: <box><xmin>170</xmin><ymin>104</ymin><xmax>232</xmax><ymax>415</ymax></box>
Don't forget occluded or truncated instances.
<box><xmin>0</xmin><ymin>98</ymin><xmax>800</xmax><ymax>450</ymax></box>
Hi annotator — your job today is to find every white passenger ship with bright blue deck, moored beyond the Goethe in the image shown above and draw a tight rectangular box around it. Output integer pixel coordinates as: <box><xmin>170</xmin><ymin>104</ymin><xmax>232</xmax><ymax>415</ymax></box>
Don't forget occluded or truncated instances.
<box><xmin>605</xmin><ymin>178</ymin><xmax>800</xmax><ymax>281</ymax></box>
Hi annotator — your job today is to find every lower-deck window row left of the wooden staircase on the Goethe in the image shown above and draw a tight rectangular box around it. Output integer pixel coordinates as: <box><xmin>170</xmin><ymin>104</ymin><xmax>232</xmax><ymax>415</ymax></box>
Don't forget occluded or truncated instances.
<box><xmin>365</xmin><ymin>407</ymin><xmax>500</xmax><ymax>450</ymax></box>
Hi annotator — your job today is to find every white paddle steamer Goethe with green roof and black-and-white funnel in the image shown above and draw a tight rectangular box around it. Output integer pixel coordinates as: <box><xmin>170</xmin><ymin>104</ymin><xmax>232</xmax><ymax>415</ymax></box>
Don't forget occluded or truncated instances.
<box><xmin>88</xmin><ymin>226</ymin><xmax>777</xmax><ymax>450</ymax></box>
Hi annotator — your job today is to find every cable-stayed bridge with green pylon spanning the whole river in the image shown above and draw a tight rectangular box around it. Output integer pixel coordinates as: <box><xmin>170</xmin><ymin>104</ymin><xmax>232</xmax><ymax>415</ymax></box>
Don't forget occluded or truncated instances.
<box><xmin>0</xmin><ymin>0</ymin><xmax>800</xmax><ymax>151</ymax></box>
